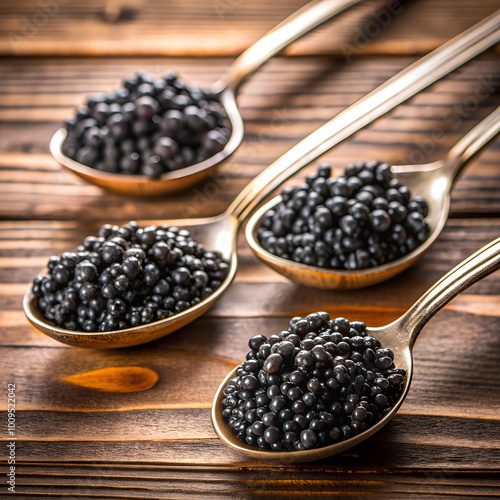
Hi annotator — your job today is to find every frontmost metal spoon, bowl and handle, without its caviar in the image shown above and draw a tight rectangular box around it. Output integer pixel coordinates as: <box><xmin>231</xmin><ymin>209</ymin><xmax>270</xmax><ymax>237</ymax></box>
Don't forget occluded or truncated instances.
<box><xmin>212</xmin><ymin>238</ymin><xmax>500</xmax><ymax>464</ymax></box>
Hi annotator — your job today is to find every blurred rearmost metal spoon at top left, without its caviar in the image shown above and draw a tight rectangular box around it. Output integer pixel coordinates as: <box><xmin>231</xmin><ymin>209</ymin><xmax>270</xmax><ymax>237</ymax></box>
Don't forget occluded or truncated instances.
<box><xmin>50</xmin><ymin>0</ymin><xmax>362</xmax><ymax>196</ymax></box>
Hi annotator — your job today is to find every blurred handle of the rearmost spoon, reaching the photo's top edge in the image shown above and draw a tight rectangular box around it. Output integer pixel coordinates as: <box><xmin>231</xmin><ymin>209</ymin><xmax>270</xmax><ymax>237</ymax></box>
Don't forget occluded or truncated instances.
<box><xmin>211</xmin><ymin>0</ymin><xmax>362</xmax><ymax>94</ymax></box>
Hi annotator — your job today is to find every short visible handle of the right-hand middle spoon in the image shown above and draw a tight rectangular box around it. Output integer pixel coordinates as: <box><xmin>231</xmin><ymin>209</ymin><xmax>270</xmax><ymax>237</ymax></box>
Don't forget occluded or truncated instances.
<box><xmin>444</xmin><ymin>106</ymin><xmax>500</xmax><ymax>183</ymax></box>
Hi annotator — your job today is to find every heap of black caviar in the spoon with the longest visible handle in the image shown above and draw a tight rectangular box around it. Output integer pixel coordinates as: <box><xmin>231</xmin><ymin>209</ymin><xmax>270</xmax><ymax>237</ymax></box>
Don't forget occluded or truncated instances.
<box><xmin>32</xmin><ymin>222</ymin><xmax>229</xmax><ymax>332</ymax></box>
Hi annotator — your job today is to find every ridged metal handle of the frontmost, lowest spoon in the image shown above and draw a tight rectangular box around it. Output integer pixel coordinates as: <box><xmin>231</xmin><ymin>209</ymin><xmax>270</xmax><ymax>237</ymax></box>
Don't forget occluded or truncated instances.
<box><xmin>395</xmin><ymin>238</ymin><xmax>500</xmax><ymax>348</ymax></box>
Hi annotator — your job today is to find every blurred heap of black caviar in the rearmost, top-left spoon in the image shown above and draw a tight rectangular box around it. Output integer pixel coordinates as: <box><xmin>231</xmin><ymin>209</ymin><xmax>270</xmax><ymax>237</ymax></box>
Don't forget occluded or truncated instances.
<box><xmin>63</xmin><ymin>71</ymin><xmax>231</xmax><ymax>179</ymax></box>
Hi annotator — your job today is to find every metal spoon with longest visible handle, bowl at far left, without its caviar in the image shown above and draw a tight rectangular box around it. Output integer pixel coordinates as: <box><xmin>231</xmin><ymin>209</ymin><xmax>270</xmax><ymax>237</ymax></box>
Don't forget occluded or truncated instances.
<box><xmin>23</xmin><ymin>11</ymin><xmax>500</xmax><ymax>349</ymax></box>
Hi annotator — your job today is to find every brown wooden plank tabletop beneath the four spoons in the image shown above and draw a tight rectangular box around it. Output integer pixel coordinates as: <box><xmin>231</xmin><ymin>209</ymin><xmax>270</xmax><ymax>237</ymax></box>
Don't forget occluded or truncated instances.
<box><xmin>0</xmin><ymin>0</ymin><xmax>500</xmax><ymax>499</ymax></box>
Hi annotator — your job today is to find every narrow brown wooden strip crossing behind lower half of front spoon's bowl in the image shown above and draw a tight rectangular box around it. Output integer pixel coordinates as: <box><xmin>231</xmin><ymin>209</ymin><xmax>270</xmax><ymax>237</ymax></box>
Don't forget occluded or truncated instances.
<box><xmin>7</xmin><ymin>404</ymin><xmax>500</xmax><ymax>444</ymax></box>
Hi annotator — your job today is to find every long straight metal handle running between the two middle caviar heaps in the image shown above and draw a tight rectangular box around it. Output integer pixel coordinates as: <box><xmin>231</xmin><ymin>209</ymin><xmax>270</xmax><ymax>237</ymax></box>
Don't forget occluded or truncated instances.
<box><xmin>227</xmin><ymin>10</ymin><xmax>500</xmax><ymax>222</ymax></box>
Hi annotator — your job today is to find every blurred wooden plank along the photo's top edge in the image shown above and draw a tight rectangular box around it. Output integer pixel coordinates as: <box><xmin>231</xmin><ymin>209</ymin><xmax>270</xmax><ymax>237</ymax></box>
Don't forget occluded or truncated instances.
<box><xmin>0</xmin><ymin>0</ymin><xmax>498</xmax><ymax>58</ymax></box>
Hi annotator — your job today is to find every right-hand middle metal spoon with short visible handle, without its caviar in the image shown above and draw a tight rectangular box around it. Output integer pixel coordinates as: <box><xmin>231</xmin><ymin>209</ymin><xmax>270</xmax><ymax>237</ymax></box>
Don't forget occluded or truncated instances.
<box><xmin>246</xmin><ymin>108</ymin><xmax>500</xmax><ymax>290</ymax></box>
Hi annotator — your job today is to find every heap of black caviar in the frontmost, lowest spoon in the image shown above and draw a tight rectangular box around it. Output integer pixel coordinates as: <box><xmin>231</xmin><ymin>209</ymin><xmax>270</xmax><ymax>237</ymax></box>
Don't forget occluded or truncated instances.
<box><xmin>222</xmin><ymin>312</ymin><xmax>406</xmax><ymax>451</ymax></box>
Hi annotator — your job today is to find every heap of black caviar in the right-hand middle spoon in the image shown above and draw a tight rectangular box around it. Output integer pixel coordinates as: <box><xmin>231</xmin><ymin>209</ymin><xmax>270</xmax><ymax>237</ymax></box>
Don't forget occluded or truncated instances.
<box><xmin>257</xmin><ymin>161</ymin><xmax>430</xmax><ymax>270</ymax></box>
